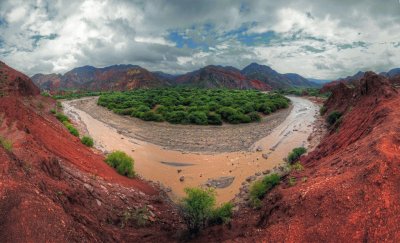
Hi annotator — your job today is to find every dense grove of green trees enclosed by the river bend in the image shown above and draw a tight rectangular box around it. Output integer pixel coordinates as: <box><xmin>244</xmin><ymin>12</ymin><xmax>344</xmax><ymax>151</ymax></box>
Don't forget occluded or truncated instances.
<box><xmin>98</xmin><ymin>88</ymin><xmax>290</xmax><ymax>125</ymax></box>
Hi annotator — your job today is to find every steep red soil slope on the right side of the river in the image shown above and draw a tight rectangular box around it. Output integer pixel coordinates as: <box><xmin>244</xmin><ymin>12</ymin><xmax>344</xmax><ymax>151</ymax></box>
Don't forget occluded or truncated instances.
<box><xmin>201</xmin><ymin>72</ymin><xmax>400</xmax><ymax>242</ymax></box>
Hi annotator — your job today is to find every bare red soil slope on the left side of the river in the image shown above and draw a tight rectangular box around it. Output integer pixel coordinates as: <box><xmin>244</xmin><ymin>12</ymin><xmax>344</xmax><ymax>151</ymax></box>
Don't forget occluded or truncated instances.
<box><xmin>0</xmin><ymin>63</ymin><xmax>179</xmax><ymax>242</ymax></box>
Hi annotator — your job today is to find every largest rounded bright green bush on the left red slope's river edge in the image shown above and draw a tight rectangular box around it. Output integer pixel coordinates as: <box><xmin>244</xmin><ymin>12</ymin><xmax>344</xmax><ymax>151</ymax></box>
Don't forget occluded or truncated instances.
<box><xmin>105</xmin><ymin>151</ymin><xmax>135</xmax><ymax>178</ymax></box>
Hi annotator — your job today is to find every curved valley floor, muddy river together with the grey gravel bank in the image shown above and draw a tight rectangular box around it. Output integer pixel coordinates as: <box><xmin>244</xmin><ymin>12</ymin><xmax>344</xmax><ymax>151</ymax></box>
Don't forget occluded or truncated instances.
<box><xmin>63</xmin><ymin>97</ymin><xmax>318</xmax><ymax>202</ymax></box>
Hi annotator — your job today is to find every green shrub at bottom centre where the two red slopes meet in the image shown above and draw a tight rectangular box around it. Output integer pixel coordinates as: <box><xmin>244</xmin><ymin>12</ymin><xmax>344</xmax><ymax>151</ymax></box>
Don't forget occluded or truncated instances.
<box><xmin>181</xmin><ymin>188</ymin><xmax>215</xmax><ymax>233</ymax></box>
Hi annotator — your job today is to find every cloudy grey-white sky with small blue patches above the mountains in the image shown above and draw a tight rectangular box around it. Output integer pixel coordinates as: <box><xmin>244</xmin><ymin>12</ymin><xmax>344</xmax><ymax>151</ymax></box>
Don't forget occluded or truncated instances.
<box><xmin>0</xmin><ymin>0</ymin><xmax>400</xmax><ymax>79</ymax></box>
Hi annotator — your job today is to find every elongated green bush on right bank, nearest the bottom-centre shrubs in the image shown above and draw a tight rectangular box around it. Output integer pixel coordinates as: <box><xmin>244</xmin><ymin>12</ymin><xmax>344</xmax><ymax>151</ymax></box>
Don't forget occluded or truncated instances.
<box><xmin>250</xmin><ymin>174</ymin><xmax>281</xmax><ymax>208</ymax></box>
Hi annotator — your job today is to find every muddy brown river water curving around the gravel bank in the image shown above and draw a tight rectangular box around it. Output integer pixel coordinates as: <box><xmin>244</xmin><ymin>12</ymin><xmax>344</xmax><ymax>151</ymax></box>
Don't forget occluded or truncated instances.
<box><xmin>62</xmin><ymin>97</ymin><xmax>318</xmax><ymax>203</ymax></box>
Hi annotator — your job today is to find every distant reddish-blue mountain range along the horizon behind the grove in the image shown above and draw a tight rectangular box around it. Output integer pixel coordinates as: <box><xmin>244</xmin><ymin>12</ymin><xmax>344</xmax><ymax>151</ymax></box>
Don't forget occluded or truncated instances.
<box><xmin>31</xmin><ymin>63</ymin><xmax>320</xmax><ymax>91</ymax></box>
